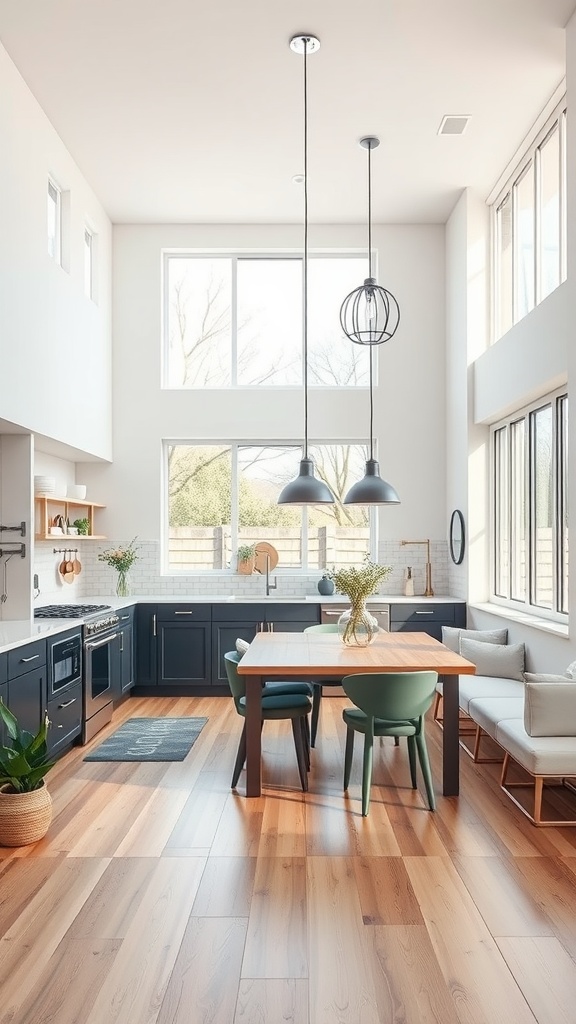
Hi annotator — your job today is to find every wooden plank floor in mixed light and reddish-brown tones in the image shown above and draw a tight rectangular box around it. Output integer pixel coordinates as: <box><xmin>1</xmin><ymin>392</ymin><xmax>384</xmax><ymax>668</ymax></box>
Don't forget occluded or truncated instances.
<box><xmin>0</xmin><ymin>697</ymin><xmax>576</xmax><ymax>1024</ymax></box>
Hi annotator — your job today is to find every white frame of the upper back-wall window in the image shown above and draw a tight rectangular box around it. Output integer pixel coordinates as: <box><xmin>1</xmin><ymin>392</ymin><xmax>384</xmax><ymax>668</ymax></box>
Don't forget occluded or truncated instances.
<box><xmin>160</xmin><ymin>248</ymin><xmax>378</xmax><ymax>391</ymax></box>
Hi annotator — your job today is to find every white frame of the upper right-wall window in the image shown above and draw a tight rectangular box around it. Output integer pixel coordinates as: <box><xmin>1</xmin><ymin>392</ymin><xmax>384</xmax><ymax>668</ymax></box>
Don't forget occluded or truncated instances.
<box><xmin>490</xmin><ymin>95</ymin><xmax>568</xmax><ymax>344</ymax></box>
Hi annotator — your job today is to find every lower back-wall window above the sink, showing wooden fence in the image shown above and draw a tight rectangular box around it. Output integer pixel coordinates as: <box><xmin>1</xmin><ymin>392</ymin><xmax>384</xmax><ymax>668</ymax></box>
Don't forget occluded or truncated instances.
<box><xmin>165</xmin><ymin>442</ymin><xmax>376</xmax><ymax>572</ymax></box>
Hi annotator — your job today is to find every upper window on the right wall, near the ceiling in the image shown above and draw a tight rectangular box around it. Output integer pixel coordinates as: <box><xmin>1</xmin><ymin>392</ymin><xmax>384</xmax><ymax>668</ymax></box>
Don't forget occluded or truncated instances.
<box><xmin>492</xmin><ymin>103</ymin><xmax>566</xmax><ymax>338</ymax></box>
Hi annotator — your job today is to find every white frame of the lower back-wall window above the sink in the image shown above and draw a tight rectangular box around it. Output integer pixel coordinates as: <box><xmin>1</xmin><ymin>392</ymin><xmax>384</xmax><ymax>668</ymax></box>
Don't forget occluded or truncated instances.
<box><xmin>161</xmin><ymin>437</ymin><xmax>378</xmax><ymax>579</ymax></box>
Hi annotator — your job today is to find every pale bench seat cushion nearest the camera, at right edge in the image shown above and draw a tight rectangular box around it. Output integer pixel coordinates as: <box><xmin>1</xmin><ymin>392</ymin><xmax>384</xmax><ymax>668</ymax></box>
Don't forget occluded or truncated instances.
<box><xmin>496</xmin><ymin>718</ymin><xmax>576</xmax><ymax>778</ymax></box>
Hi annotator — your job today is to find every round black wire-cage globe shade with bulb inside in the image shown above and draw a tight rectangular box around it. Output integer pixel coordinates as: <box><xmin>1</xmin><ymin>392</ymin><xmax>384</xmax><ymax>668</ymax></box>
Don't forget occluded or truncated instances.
<box><xmin>340</xmin><ymin>278</ymin><xmax>400</xmax><ymax>345</ymax></box>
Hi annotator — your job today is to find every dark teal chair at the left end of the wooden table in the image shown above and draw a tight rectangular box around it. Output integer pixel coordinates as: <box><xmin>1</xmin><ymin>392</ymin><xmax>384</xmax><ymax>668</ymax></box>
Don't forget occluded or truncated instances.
<box><xmin>224</xmin><ymin>650</ymin><xmax>312</xmax><ymax>793</ymax></box>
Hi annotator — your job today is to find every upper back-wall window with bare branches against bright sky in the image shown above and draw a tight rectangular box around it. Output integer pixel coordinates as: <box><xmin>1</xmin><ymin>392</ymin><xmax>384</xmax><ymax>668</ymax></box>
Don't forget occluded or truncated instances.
<box><xmin>163</xmin><ymin>253</ymin><xmax>368</xmax><ymax>388</ymax></box>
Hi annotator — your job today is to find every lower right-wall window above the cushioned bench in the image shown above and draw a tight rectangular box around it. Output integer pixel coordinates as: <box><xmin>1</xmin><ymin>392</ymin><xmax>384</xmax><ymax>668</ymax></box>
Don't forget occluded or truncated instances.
<box><xmin>492</xmin><ymin>392</ymin><xmax>568</xmax><ymax>615</ymax></box>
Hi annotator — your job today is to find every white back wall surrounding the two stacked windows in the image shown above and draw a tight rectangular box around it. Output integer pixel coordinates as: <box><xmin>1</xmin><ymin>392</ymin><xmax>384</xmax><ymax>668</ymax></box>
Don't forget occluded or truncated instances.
<box><xmin>79</xmin><ymin>224</ymin><xmax>446</xmax><ymax>550</ymax></box>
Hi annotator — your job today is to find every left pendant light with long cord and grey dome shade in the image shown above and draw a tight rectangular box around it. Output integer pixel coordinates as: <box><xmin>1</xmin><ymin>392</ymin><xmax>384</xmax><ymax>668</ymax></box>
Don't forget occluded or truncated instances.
<box><xmin>278</xmin><ymin>35</ymin><xmax>335</xmax><ymax>505</ymax></box>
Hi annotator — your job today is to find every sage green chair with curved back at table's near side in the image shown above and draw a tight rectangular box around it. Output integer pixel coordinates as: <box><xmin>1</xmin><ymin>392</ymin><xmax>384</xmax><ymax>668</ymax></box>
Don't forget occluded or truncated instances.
<box><xmin>342</xmin><ymin>672</ymin><xmax>438</xmax><ymax>816</ymax></box>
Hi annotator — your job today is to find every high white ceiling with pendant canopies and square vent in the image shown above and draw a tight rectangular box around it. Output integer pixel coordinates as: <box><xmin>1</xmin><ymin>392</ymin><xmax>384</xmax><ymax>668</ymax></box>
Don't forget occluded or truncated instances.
<box><xmin>0</xmin><ymin>0</ymin><xmax>575</xmax><ymax>223</ymax></box>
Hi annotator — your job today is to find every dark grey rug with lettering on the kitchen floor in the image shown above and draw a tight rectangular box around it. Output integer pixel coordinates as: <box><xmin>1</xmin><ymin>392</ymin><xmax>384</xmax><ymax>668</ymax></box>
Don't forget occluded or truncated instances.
<box><xmin>84</xmin><ymin>718</ymin><xmax>208</xmax><ymax>761</ymax></box>
